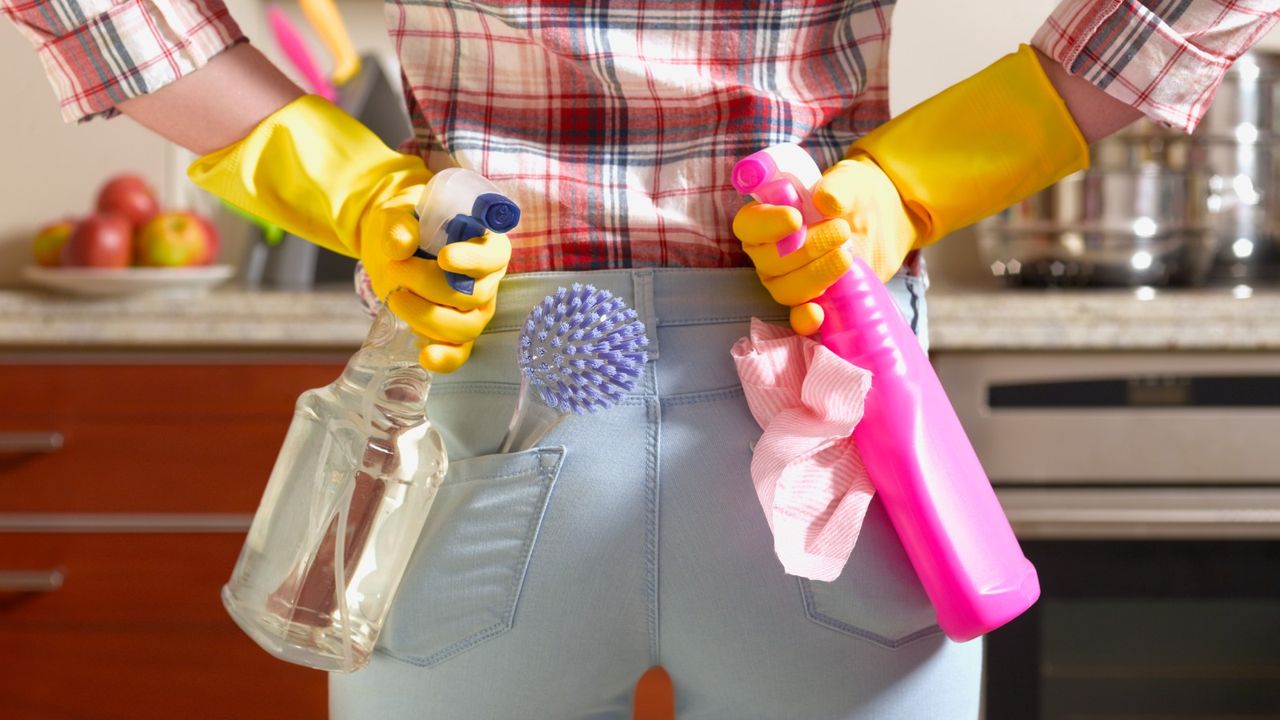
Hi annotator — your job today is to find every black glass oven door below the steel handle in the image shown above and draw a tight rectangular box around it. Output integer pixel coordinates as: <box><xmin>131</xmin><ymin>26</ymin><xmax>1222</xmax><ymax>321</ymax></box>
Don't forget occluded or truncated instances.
<box><xmin>986</xmin><ymin>539</ymin><xmax>1280</xmax><ymax>720</ymax></box>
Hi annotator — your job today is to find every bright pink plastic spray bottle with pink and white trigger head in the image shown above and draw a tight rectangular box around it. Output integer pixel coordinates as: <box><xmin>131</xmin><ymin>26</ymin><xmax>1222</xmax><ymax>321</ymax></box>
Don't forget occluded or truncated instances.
<box><xmin>732</xmin><ymin>143</ymin><xmax>1039</xmax><ymax>642</ymax></box>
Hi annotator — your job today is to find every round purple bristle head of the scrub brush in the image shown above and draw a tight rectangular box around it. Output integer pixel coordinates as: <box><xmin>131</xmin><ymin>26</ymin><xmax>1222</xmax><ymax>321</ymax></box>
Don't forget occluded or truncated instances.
<box><xmin>520</xmin><ymin>283</ymin><xmax>649</xmax><ymax>415</ymax></box>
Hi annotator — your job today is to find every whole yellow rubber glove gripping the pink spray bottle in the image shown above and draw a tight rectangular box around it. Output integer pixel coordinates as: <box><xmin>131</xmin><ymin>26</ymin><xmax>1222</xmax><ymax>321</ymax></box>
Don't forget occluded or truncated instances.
<box><xmin>733</xmin><ymin>45</ymin><xmax>1088</xmax><ymax>334</ymax></box>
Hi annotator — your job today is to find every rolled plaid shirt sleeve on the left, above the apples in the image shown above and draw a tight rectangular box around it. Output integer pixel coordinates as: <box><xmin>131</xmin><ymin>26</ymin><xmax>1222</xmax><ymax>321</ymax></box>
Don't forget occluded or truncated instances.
<box><xmin>0</xmin><ymin>0</ymin><xmax>244</xmax><ymax>122</ymax></box>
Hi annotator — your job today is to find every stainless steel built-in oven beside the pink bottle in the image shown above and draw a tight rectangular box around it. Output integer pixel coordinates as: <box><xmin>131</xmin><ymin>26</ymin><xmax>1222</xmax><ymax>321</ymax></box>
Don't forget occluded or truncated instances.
<box><xmin>934</xmin><ymin>352</ymin><xmax>1280</xmax><ymax>720</ymax></box>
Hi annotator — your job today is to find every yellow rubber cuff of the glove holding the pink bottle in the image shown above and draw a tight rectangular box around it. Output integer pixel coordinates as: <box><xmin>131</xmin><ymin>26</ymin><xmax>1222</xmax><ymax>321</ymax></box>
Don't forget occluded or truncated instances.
<box><xmin>846</xmin><ymin>45</ymin><xmax>1089</xmax><ymax>247</ymax></box>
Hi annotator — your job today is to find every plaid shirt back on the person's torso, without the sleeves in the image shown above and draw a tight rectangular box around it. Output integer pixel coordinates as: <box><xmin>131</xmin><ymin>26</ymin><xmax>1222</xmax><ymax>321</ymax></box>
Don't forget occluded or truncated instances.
<box><xmin>385</xmin><ymin>0</ymin><xmax>892</xmax><ymax>273</ymax></box>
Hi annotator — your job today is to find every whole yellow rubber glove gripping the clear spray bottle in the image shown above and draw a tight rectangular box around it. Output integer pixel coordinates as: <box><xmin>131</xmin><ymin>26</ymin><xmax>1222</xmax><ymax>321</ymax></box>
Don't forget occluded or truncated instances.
<box><xmin>187</xmin><ymin>95</ymin><xmax>511</xmax><ymax>373</ymax></box>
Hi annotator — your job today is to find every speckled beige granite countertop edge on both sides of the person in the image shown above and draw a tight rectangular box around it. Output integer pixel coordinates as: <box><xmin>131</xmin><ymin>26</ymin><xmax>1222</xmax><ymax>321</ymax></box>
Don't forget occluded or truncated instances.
<box><xmin>0</xmin><ymin>283</ymin><xmax>1280</xmax><ymax>351</ymax></box>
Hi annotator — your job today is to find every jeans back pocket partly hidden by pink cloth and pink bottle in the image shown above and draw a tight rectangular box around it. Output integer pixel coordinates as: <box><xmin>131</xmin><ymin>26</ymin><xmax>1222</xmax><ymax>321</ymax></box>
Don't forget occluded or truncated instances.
<box><xmin>797</xmin><ymin>497</ymin><xmax>942</xmax><ymax>648</ymax></box>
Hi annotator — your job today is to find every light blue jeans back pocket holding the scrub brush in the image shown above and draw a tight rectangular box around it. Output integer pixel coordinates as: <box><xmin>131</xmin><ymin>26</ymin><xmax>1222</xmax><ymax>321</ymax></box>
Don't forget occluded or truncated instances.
<box><xmin>378</xmin><ymin>447</ymin><xmax>564</xmax><ymax>667</ymax></box>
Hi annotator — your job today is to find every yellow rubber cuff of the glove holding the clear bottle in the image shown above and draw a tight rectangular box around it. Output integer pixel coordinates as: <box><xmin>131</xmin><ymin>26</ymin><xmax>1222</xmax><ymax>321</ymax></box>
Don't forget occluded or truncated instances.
<box><xmin>187</xmin><ymin>95</ymin><xmax>431</xmax><ymax>256</ymax></box>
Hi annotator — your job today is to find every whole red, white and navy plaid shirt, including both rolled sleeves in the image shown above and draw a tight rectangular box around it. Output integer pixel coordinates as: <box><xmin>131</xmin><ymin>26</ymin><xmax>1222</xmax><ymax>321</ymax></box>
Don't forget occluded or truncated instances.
<box><xmin>0</xmin><ymin>0</ymin><xmax>1280</xmax><ymax>272</ymax></box>
